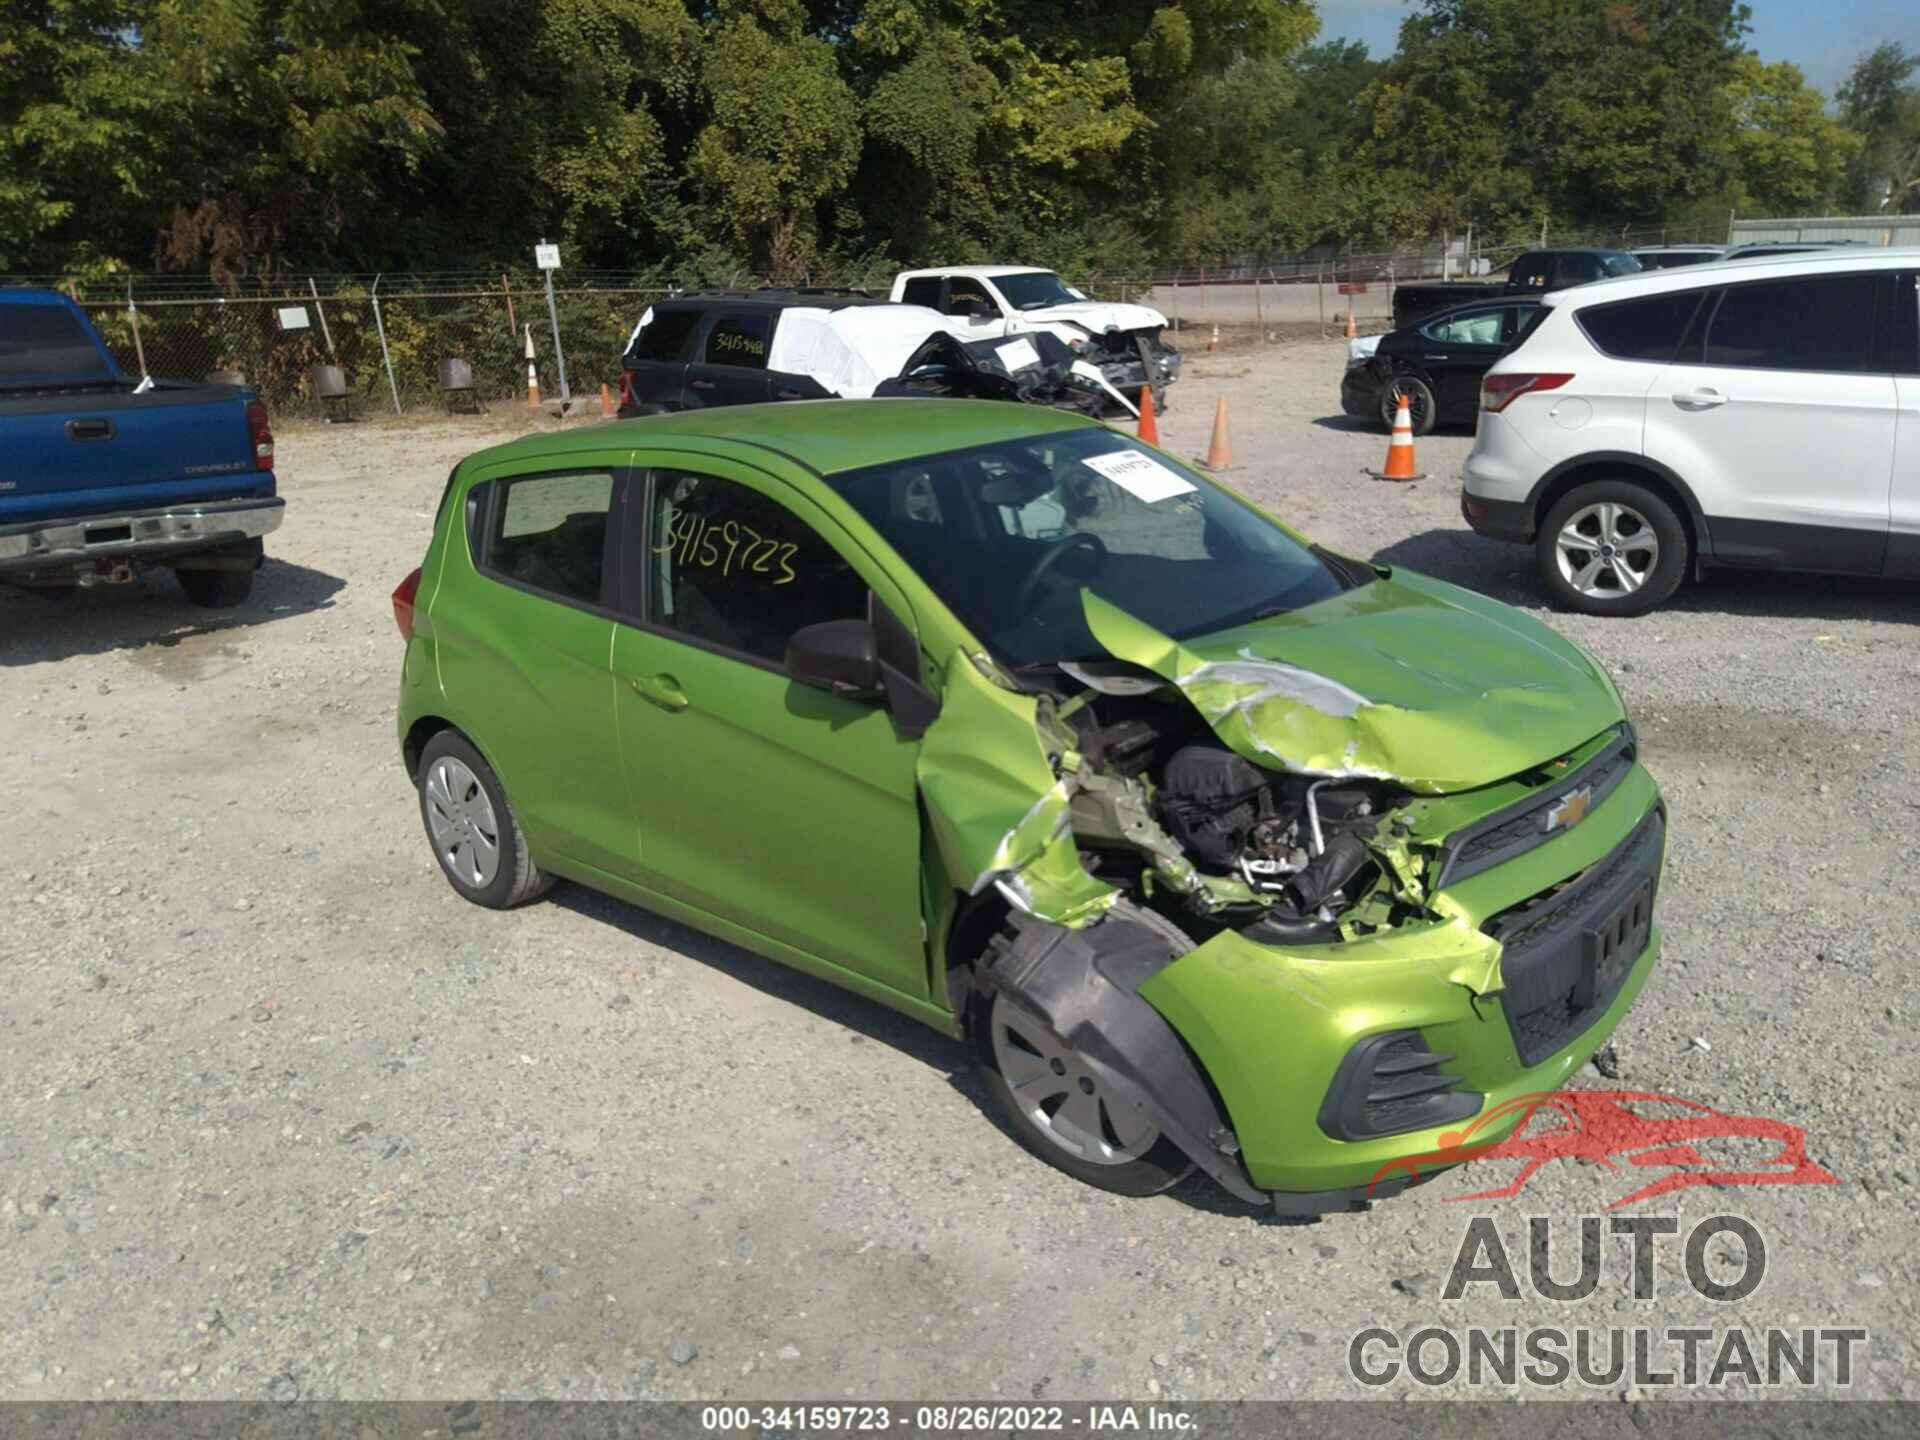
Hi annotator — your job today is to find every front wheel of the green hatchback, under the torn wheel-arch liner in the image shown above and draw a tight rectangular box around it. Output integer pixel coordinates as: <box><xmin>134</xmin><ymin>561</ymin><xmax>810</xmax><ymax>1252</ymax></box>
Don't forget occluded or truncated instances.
<box><xmin>973</xmin><ymin>900</ymin><xmax>1194</xmax><ymax>1196</ymax></box>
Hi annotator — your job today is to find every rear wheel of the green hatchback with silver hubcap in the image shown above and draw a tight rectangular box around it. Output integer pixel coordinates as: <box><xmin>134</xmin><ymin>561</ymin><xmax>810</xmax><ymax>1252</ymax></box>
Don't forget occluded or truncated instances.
<box><xmin>417</xmin><ymin>730</ymin><xmax>553</xmax><ymax>910</ymax></box>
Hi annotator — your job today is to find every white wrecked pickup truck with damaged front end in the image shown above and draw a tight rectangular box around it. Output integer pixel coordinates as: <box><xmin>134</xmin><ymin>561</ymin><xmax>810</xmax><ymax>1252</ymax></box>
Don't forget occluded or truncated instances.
<box><xmin>891</xmin><ymin>265</ymin><xmax>1181</xmax><ymax>409</ymax></box>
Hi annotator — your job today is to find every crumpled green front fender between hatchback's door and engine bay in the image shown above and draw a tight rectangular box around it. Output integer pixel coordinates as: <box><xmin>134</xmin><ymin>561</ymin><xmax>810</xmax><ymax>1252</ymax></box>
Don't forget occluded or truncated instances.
<box><xmin>916</xmin><ymin>649</ymin><xmax>1117</xmax><ymax>925</ymax></box>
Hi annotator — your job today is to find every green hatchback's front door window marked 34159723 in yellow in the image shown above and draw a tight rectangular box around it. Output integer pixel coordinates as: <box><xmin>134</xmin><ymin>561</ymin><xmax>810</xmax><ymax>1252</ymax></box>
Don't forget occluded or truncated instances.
<box><xmin>647</xmin><ymin>472</ymin><xmax>866</xmax><ymax>664</ymax></box>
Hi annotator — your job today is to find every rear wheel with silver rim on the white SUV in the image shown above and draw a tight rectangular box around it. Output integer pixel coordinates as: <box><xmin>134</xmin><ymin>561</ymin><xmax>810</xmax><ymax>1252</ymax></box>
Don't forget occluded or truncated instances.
<box><xmin>1534</xmin><ymin>480</ymin><xmax>1693</xmax><ymax>616</ymax></box>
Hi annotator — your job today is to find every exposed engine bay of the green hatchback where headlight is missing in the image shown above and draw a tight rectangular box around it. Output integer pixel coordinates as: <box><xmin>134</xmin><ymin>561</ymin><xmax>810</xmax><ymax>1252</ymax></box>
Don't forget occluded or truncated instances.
<box><xmin>1056</xmin><ymin>687</ymin><xmax>1427</xmax><ymax>945</ymax></box>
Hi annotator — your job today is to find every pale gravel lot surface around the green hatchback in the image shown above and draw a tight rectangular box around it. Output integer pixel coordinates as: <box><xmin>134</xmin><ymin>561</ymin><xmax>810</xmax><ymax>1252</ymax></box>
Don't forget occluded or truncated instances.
<box><xmin>0</xmin><ymin>340</ymin><xmax>1920</xmax><ymax>1400</ymax></box>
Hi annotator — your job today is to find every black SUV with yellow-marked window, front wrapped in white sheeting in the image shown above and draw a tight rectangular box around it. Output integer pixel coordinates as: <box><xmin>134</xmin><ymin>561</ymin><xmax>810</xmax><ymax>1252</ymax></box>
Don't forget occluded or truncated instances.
<box><xmin>620</xmin><ymin>288</ymin><xmax>887</xmax><ymax>415</ymax></box>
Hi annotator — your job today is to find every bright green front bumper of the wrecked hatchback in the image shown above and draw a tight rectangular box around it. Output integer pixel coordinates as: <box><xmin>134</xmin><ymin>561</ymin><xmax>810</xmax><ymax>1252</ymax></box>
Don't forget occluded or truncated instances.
<box><xmin>1140</xmin><ymin>766</ymin><xmax>1665</xmax><ymax>1213</ymax></box>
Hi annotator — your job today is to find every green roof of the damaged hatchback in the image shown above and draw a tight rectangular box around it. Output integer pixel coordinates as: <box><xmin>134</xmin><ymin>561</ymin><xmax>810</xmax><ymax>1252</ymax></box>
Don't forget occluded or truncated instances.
<box><xmin>449</xmin><ymin>397</ymin><xmax>1106</xmax><ymax>476</ymax></box>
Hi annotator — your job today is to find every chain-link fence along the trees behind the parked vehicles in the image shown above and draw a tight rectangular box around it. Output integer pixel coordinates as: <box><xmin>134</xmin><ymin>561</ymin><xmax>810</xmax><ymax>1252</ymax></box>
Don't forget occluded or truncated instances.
<box><xmin>37</xmin><ymin>216</ymin><xmax>1735</xmax><ymax>415</ymax></box>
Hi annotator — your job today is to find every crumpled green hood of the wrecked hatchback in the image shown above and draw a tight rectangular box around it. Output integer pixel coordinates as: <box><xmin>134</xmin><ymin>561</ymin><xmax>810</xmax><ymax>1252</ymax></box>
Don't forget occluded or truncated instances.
<box><xmin>1085</xmin><ymin>572</ymin><xmax>1626</xmax><ymax>795</ymax></box>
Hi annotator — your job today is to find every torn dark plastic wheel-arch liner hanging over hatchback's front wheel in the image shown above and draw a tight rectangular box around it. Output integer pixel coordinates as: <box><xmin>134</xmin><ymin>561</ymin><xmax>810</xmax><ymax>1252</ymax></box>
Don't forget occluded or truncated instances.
<box><xmin>983</xmin><ymin>914</ymin><xmax>1269</xmax><ymax>1204</ymax></box>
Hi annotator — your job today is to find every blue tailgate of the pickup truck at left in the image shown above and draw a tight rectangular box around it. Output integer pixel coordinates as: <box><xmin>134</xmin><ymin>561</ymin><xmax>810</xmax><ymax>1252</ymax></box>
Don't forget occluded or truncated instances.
<box><xmin>0</xmin><ymin>382</ymin><xmax>273</xmax><ymax>524</ymax></box>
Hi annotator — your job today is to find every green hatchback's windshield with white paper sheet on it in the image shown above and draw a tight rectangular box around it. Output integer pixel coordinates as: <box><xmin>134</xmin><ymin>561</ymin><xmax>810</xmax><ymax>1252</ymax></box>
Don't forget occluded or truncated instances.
<box><xmin>831</xmin><ymin>428</ymin><xmax>1340</xmax><ymax>666</ymax></box>
